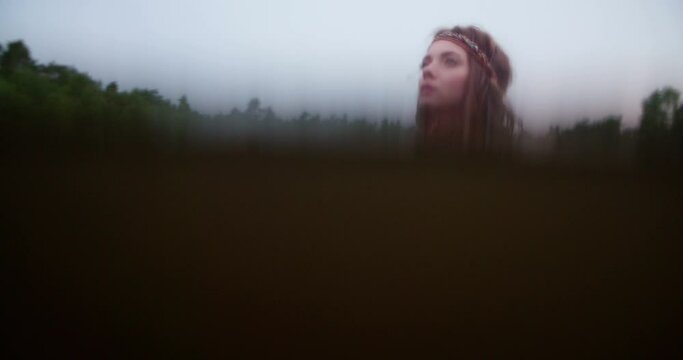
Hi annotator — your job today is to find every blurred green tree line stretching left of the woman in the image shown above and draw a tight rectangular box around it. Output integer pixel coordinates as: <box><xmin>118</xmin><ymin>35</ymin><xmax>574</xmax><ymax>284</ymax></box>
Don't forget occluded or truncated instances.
<box><xmin>0</xmin><ymin>41</ymin><xmax>413</xmax><ymax>157</ymax></box>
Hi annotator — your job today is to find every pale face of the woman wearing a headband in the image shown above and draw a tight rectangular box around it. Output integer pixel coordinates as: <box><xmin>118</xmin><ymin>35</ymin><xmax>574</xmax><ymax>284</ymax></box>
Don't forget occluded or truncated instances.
<box><xmin>418</xmin><ymin>40</ymin><xmax>469</xmax><ymax>108</ymax></box>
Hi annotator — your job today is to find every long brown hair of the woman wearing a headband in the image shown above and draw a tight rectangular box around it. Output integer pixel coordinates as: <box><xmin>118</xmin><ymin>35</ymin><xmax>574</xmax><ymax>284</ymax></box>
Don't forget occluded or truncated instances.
<box><xmin>415</xmin><ymin>26</ymin><xmax>516</xmax><ymax>154</ymax></box>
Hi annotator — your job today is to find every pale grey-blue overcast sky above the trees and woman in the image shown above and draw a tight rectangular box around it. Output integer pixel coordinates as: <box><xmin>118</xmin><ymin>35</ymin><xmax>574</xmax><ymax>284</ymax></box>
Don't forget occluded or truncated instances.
<box><xmin>0</xmin><ymin>0</ymin><xmax>683</xmax><ymax>132</ymax></box>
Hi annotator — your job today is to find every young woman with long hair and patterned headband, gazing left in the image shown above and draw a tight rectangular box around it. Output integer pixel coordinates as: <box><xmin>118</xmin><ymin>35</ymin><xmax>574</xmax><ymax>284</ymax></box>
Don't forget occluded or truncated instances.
<box><xmin>416</xmin><ymin>26</ymin><xmax>515</xmax><ymax>154</ymax></box>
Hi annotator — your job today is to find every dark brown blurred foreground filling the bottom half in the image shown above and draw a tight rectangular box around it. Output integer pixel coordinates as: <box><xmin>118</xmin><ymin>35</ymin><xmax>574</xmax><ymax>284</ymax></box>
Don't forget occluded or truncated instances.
<box><xmin>1</xmin><ymin>151</ymin><xmax>683</xmax><ymax>359</ymax></box>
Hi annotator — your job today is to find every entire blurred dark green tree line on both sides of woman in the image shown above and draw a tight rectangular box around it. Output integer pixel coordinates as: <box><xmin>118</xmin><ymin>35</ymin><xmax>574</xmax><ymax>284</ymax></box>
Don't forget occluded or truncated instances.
<box><xmin>0</xmin><ymin>41</ymin><xmax>683</xmax><ymax>169</ymax></box>
